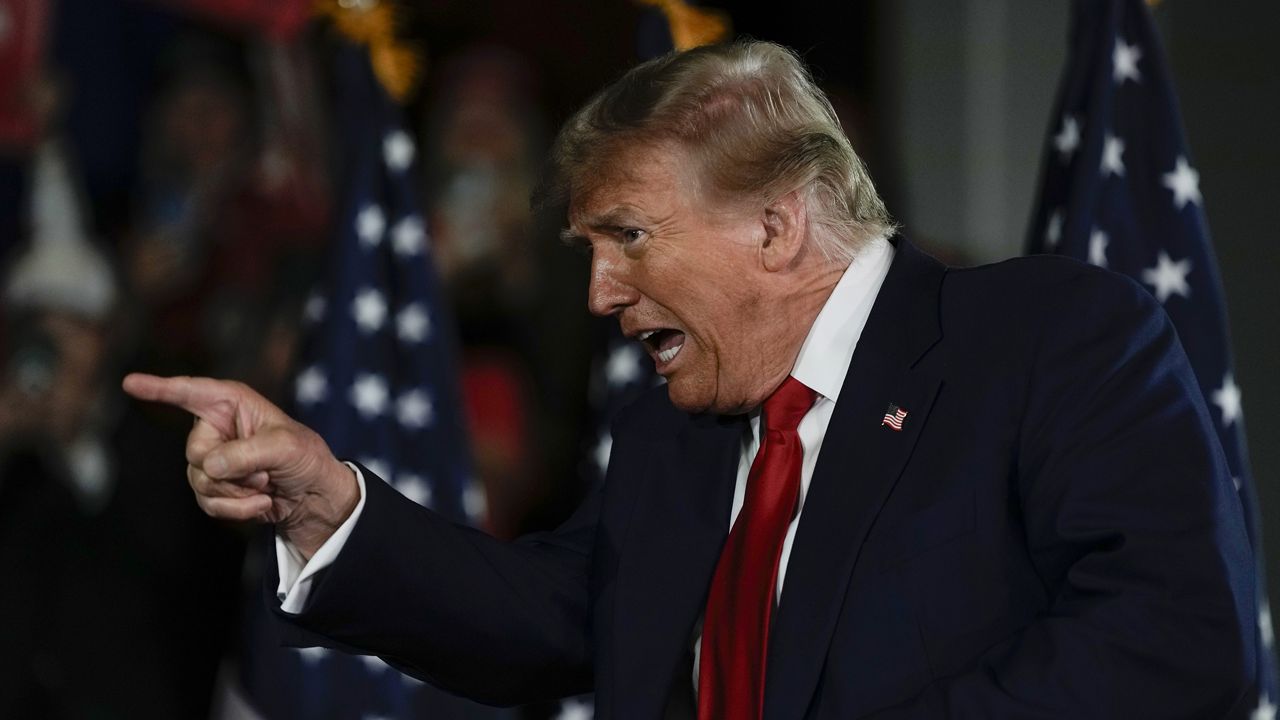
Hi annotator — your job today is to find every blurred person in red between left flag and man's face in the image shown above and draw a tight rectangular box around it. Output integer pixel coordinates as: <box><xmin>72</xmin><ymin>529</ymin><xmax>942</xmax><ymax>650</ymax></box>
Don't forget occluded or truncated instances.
<box><xmin>424</xmin><ymin>45</ymin><xmax>581</xmax><ymax>538</ymax></box>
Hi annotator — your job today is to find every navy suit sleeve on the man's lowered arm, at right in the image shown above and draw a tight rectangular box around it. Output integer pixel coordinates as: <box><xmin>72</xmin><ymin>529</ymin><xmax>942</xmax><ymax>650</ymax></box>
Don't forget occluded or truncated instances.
<box><xmin>872</xmin><ymin>272</ymin><xmax>1256</xmax><ymax>720</ymax></box>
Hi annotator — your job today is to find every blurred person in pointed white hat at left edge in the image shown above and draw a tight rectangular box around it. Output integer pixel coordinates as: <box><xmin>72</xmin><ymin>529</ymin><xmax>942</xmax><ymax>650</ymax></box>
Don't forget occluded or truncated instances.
<box><xmin>0</xmin><ymin>131</ymin><xmax>242</xmax><ymax>717</ymax></box>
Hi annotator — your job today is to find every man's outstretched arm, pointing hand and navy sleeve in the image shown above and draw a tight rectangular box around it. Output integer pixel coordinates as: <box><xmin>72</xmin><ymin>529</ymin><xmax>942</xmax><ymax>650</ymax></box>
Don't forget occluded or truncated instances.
<box><xmin>124</xmin><ymin>374</ymin><xmax>598</xmax><ymax>705</ymax></box>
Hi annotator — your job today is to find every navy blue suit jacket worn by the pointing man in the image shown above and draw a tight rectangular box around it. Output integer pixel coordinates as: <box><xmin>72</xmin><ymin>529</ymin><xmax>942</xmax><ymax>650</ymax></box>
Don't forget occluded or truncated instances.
<box><xmin>275</xmin><ymin>241</ymin><xmax>1257</xmax><ymax>720</ymax></box>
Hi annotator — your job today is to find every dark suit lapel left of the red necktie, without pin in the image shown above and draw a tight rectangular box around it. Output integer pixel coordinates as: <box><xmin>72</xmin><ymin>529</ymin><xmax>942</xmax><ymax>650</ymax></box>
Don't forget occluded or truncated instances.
<box><xmin>614</xmin><ymin>416</ymin><xmax>744</xmax><ymax>717</ymax></box>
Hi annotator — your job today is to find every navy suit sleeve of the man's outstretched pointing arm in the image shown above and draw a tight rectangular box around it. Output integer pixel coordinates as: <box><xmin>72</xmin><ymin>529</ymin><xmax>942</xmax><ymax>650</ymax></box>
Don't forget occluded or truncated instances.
<box><xmin>265</xmin><ymin>461</ymin><xmax>599</xmax><ymax>705</ymax></box>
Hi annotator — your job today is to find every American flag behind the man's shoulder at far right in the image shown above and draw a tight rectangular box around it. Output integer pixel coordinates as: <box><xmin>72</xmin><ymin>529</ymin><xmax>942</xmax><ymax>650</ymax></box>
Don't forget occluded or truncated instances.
<box><xmin>1028</xmin><ymin>0</ymin><xmax>1280</xmax><ymax>707</ymax></box>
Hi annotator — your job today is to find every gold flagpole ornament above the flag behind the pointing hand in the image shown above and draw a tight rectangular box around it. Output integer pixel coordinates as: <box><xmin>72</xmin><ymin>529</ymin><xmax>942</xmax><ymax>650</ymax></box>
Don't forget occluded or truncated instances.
<box><xmin>315</xmin><ymin>0</ymin><xmax>422</xmax><ymax>102</ymax></box>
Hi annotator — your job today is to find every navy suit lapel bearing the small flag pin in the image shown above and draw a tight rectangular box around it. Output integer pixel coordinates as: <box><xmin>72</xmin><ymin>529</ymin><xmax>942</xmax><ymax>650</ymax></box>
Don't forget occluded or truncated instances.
<box><xmin>764</xmin><ymin>241</ymin><xmax>946</xmax><ymax>720</ymax></box>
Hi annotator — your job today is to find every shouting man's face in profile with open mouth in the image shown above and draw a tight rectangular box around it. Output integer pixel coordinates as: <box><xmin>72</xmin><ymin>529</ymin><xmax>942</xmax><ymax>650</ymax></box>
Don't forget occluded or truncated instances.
<box><xmin>570</xmin><ymin>147</ymin><xmax>795</xmax><ymax>414</ymax></box>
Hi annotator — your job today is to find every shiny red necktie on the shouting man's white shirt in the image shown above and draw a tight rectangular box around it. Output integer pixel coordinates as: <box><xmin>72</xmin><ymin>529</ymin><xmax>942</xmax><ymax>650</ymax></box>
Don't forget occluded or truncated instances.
<box><xmin>698</xmin><ymin>377</ymin><xmax>815</xmax><ymax>720</ymax></box>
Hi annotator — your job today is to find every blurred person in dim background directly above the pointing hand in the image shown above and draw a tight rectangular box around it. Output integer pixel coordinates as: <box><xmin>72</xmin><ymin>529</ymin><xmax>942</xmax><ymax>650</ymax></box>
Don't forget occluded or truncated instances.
<box><xmin>124</xmin><ymin>35</ymin><xmax>328</xmax><ymax>391</ymax></box>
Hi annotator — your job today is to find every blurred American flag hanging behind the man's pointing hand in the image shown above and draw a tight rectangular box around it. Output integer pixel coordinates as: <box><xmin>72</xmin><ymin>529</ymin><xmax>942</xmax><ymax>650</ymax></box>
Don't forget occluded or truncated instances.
<box><xmin>242</xmin><ymin>40</ymin><xmax>509</xmax><ymax>719</ymax></box>
